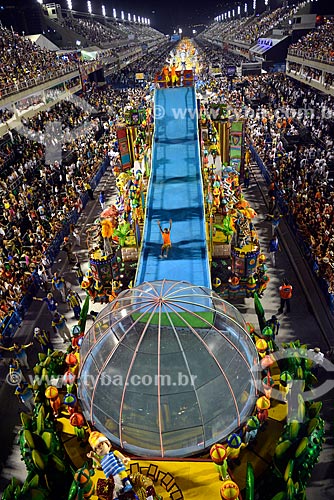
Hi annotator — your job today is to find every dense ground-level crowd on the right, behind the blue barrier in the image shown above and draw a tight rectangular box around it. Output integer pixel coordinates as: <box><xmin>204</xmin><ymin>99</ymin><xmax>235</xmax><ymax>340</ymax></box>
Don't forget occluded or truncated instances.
<box><xmin>241</xmin><ymin>74</ymin><xmax>334</xmax><ymax>293</ymax></box>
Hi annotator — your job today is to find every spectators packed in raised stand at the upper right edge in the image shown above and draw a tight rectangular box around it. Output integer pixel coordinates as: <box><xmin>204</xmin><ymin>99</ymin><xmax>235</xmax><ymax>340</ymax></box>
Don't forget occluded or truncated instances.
<box><xmin>288</xmin><ymin>19</ymin><xmax>334</xmax><ymax>64</ymax></box>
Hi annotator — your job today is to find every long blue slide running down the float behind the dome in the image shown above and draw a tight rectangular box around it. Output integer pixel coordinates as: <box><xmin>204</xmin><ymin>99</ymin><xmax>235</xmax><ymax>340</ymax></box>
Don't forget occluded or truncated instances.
<box><xmin>135</xmin><ymin>87</ymin><xmax>211</xmax><ymax>288</ymax></box>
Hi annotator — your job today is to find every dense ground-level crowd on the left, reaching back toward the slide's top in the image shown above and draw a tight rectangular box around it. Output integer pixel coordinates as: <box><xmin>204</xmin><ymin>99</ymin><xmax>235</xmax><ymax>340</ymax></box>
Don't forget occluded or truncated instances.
<box><xmin>0</xmin><ymin>78</ymin><xmax>153</xmax><ymax>329</ymax></box>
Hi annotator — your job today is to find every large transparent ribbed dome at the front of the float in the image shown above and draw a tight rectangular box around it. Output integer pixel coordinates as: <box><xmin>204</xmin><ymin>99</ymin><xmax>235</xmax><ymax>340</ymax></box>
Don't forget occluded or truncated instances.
<box><xmin>78</xmin><ymin>280</ymin><xmax>259</xmax><ymax>457</ymax></box>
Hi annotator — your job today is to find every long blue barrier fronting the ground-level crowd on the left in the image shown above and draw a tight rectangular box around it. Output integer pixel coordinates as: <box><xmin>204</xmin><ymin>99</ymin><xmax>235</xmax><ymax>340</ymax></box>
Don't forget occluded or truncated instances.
<box><xmin>0</xmin><ymin>158</ymin><xmax>109</xmax><ymax>344</ymax></box>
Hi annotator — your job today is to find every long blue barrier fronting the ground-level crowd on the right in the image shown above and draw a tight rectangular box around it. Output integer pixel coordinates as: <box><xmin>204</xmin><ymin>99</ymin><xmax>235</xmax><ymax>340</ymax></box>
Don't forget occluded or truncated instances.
<box><xmin>249</xmin><ymin>139</ymin><xmax>334</xmax><ymax>315</ymax></box>
